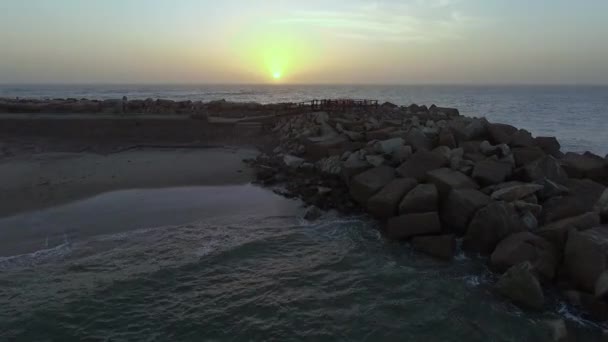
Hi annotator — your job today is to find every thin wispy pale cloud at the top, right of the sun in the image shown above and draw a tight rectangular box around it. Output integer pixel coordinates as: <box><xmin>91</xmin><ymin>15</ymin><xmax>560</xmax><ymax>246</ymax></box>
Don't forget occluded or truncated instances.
<box><xmin>278</xmin><ymin>0</ymin><xmax>481</xmax><ymax>42</ymax></box>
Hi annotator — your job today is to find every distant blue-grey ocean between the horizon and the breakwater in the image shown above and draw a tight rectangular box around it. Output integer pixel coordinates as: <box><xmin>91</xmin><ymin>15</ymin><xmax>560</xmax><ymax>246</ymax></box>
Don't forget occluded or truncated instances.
<box><xmin>0</xmin><ymin>85</ymin><xmax>608</xmax><ymax>156</ymax></box>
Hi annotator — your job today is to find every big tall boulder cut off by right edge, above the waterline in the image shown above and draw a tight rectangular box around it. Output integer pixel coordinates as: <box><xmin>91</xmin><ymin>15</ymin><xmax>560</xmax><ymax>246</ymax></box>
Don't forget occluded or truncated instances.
<box><xmin>564</xmin><ymin>227</ymin><xmax>608</xmax><ymax>293</ymax></box>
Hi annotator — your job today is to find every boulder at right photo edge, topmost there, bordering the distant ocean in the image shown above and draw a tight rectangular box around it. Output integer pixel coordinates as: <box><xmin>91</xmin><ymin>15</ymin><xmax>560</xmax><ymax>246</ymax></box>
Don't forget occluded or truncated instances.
<box><xmin>561</xmin><ymin>152</ymin><xmax>608</xmax><ymax>184</ymax></box>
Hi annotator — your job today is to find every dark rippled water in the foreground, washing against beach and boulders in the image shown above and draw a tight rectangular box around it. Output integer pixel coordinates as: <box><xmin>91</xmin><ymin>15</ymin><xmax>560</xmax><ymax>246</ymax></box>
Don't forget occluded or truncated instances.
<box><xmin>0</xmin><ymin>185</ymin><xmax>601</xmax><ymax>342</ymax></box>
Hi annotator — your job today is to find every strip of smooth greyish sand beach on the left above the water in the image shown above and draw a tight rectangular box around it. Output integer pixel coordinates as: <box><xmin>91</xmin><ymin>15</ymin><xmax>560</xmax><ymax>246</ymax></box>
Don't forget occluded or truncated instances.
<box><xmin>0</xmin><ymin>148</ymin><xmax>257</xmax><ymax>217</ymax></box>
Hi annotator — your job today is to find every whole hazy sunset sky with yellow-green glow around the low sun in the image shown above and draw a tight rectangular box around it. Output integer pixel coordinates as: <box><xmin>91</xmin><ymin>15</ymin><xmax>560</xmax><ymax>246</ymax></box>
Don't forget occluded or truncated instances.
<box><xmin>0</xmin><ymin>0</ymin><xmax>608</xmax><ymax>84</ymax></box>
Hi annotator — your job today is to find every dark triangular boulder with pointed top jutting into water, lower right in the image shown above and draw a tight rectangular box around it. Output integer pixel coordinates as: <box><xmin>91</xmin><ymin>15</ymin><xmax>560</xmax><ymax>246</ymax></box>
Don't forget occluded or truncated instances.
<box><xmin>496</xmin><ymin>262</ymin><xmax>545</xmax><ymax>310</ymax></box>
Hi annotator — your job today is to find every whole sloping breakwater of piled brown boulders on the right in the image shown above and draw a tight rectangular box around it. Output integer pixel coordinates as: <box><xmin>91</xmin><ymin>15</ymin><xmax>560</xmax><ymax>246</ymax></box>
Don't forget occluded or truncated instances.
<box><xmin>248</xmin><ymin>103</ymin><xmax>608</xmax><ymax>320</ymax></box>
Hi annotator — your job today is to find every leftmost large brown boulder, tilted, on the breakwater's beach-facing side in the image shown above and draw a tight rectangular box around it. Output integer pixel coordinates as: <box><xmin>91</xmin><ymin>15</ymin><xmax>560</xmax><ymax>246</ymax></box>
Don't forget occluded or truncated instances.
<box><xmin>349</xmin><ymin>166</ymin><xmax>395</xmax><ymax>205</ymax></box>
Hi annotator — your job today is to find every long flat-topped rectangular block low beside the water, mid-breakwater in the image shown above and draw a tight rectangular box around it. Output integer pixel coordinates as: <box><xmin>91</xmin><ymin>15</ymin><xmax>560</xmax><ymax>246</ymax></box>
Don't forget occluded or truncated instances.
<box><xmin>386</xmin><ymin>212</ymin><xmax>441</xmax><ymax>240</ymax></box>
